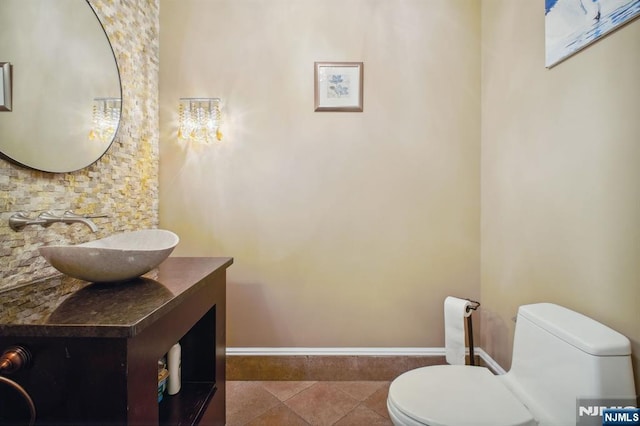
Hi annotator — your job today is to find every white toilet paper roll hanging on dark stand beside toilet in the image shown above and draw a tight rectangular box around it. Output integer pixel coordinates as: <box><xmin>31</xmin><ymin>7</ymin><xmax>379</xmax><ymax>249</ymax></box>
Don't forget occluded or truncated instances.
<box><xmin>444</xmin><ymin>296</ymin><xmax>471</xmax><ymax>365</ymax></box>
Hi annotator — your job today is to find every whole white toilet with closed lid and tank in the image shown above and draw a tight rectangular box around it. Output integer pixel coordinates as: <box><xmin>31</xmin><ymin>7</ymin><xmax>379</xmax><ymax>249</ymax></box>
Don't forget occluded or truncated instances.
<box><xmin>387</xmin><ymin>303</ymin><xmax>636</xmax><ymax>426</ymax></box>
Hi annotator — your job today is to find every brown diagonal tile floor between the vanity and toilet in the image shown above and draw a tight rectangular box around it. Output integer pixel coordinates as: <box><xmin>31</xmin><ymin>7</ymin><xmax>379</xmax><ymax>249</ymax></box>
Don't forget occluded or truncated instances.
<box><xmin>226</xmin><ymin>381</ymin><xmax>392</xmax><ymax>426</ymax></box>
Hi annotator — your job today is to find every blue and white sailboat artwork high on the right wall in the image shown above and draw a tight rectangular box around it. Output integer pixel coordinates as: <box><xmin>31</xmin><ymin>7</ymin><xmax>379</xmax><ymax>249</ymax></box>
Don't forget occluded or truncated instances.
<box><xmin>544</xmin><ymin>0</ymin><xmax>640</xmax><ymax>68</ymax></box>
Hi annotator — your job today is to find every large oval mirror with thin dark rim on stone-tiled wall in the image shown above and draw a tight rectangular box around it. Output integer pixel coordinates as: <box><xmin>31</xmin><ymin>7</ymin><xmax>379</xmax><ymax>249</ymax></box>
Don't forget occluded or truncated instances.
<box><xmin>0</xmin><ymin>0</ymin><xmax>122</xmax><ymax>173</ymax></box>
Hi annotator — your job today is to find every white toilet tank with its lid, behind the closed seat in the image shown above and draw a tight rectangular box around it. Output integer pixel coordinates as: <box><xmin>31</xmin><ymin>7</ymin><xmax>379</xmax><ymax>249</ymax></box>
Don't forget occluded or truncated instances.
<box><xmin>501</xmin><ymin>303</ymin><xmax>635</xmax><ymax>426</ymax></box>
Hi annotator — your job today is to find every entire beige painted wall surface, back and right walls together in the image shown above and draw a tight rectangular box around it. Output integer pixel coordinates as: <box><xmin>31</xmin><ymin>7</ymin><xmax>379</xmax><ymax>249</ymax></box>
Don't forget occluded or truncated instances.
<box><xmin>160</xmin><ymin>0</ymin><xmax>640</xmax><ymax>382</ymax></box>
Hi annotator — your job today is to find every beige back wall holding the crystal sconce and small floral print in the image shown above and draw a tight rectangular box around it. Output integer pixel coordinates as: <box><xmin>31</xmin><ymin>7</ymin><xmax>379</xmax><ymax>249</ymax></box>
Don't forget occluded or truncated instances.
<box><xmin>160</xmin><ymin>0</ymin><xmax>480</xmax><ymax>347</ymax></box>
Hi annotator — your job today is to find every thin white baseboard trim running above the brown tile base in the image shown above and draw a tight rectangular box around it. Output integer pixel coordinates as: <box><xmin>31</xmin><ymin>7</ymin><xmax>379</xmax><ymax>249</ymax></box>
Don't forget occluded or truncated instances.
<box><xmin>226</xmin><ymin>347</ymin><xmax>506</xmax><ymax>374</ymax></box>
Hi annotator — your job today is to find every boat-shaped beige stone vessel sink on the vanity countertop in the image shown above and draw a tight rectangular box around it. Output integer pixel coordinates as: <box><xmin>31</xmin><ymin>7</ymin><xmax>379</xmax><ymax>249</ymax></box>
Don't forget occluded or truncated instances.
<box><xmin>39</xmin><ymin>229</ymin><xmax>180</xmax><ymax>283</ymax></box>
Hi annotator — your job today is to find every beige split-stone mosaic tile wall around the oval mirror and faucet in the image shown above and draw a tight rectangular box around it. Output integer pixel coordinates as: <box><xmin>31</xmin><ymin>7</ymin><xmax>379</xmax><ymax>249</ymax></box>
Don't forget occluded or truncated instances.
<box><xmin>0</xmin><ymin>0</ymin><xmax>159</xmax><ymax>288</ymax></box>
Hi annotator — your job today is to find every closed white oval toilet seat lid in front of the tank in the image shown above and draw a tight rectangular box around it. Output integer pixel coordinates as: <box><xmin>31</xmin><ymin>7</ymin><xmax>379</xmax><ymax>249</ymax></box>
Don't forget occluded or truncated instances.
<box><xmin>388</xmin><ymin>365</ymin><xmax>537</xmax><ymax>426</ymax></box>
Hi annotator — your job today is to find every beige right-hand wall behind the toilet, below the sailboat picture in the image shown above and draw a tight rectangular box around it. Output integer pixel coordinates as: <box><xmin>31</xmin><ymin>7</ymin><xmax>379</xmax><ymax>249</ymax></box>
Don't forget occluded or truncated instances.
<box><xmin>481</xmin><ymin>0</ymin><xmax>640</xmax><ymax>392</ymax></box>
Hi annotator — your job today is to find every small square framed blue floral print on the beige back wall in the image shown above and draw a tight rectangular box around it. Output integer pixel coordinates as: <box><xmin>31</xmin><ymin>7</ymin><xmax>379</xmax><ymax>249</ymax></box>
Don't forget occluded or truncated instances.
<box><xmin>313</xmin><ymin>62</ymin><xmax>364</xmax><ymax>112</ymax></box>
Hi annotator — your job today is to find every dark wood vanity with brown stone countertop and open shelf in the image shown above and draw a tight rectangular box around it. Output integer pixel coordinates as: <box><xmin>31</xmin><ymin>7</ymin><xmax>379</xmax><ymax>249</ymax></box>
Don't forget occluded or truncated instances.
<box><xmin>0</xmin><ymin>257</ymin><xmax>233</xmax><ymax>426</ymax></box>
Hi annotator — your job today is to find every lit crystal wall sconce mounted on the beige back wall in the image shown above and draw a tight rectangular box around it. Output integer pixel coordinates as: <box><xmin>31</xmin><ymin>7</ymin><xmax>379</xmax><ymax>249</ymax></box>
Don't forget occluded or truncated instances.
<box><xmin>178</xmin><ymin>98</ymin><xmax>222</xmax><ymax>143</ymax></box>
